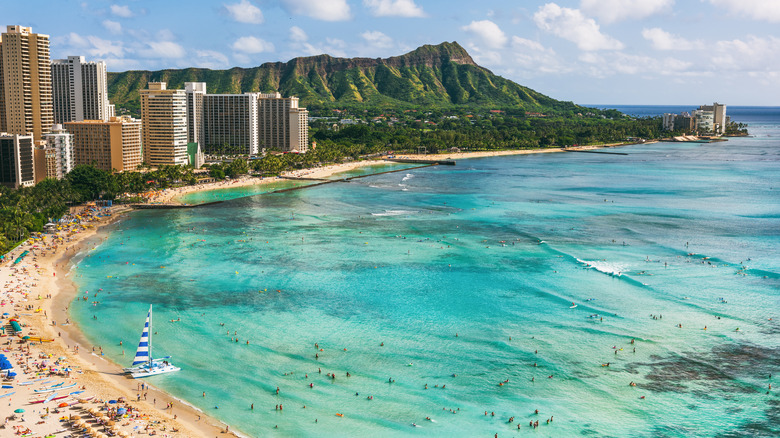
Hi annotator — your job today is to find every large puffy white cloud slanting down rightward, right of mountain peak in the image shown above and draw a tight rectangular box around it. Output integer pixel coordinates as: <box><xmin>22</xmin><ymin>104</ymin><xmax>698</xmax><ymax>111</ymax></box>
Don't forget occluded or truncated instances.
<box><xmin>534</xmin><ymin>3</ymin><xmax>623</xmax><ymax>50</ymax></box>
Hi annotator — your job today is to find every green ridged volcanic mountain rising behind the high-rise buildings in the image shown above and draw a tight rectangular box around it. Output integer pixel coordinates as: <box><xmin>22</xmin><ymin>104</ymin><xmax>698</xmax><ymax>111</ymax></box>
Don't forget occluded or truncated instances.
<box><xmin>108</xmin><ymin>42</ymin><xmax>583</xmax><ymax>114</ymax></box>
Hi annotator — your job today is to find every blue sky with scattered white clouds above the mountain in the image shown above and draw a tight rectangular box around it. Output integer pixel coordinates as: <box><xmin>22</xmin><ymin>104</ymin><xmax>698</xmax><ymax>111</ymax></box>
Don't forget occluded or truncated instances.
<box><xmin>6</xmin><ymin>0</ymin><xmax>780</xmax><ymax>106</ymax></box>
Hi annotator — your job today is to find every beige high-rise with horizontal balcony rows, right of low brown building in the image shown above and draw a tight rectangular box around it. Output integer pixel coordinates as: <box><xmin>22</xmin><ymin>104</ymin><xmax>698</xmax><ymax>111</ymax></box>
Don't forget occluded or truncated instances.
<box><xmin>140</xmin><ymin>82</ymin><xmax>188</xmax><ymax>166</ymax></box>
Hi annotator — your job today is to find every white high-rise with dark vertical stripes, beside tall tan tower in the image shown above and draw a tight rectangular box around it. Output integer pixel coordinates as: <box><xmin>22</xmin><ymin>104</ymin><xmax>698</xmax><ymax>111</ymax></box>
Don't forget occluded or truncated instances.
<box><xmin>51</xmin><ymin>56</ymin><xmax>113</xmax><ymax>123</ymax></box>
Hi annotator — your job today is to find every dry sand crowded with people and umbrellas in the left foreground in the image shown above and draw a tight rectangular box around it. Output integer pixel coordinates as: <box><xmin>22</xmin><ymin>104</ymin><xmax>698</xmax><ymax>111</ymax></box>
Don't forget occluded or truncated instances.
<box><xmin>0</xmin><ymin>206</ymin><xmax>230</xmax><ymax>437</ymax></box>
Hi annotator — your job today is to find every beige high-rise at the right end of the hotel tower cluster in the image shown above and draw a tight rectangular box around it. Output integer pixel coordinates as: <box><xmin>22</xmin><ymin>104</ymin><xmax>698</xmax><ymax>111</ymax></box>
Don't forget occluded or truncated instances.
<box><xmin>258</xmin><ymin>93</ymin><xmax>309</xmax><ymax>152</ymax></box>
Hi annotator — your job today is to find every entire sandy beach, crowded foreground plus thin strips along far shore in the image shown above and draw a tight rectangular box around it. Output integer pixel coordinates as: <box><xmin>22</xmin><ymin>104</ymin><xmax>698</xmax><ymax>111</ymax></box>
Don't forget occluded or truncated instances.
<box><xmin>0</xmin><ymin>145</ymin><xmax>644</xmax><ymax>437</ymax></box>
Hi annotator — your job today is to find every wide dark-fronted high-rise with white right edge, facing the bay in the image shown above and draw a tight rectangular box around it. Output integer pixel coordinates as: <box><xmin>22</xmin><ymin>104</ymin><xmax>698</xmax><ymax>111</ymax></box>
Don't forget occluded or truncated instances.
<box><xmin>202</xmin><ymin>93</ymin><xmax>259</xmax><ymax>154</ymax></box>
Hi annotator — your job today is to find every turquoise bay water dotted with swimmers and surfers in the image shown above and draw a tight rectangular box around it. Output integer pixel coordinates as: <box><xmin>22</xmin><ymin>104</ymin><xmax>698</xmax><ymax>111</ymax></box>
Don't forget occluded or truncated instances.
<box><xmin>71</xmin><ymin>114</ymin><xmax>780</xmax><ymax>437</ymax></box>
